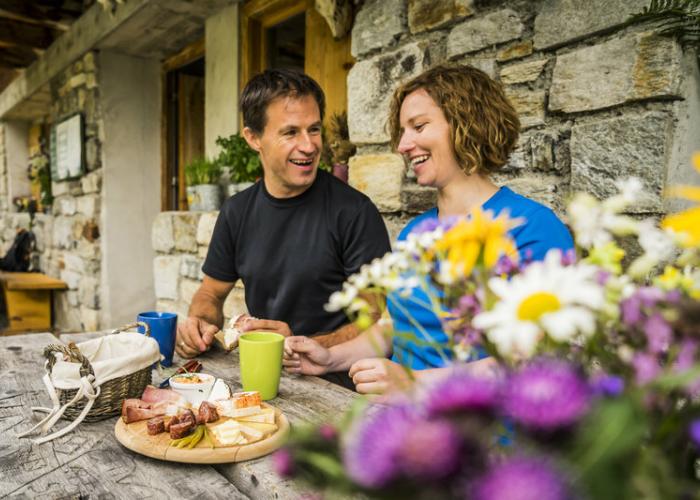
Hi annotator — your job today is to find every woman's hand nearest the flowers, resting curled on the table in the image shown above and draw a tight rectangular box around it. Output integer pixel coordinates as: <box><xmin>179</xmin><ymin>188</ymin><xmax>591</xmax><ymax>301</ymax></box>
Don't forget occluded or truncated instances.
<box><xmin>348</xmin><ymin>358</ymin><xmax>413</xmax><ymax>394</ymax></box>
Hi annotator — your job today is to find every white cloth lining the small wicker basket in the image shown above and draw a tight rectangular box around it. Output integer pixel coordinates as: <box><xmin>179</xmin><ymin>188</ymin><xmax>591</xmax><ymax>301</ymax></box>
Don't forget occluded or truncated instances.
<box><xmin>51</xmin><ymin>332</ymin><xmax>162</xmax><ymax>390</ymax></box>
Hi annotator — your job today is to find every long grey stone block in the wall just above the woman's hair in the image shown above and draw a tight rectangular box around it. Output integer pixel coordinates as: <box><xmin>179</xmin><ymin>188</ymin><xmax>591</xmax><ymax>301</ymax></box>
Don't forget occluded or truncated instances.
<box><xmin>447</xmin><ymin>9</ymin><xmax>525</xmax><ymax>59</ymax></box>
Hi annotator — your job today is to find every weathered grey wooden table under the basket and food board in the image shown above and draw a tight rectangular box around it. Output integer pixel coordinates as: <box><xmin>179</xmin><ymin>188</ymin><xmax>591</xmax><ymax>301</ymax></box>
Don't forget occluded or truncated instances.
<box><xmin>0</xmin><ymin>333</ymin><xmax>356</xmax><ymax>500</ymax></box>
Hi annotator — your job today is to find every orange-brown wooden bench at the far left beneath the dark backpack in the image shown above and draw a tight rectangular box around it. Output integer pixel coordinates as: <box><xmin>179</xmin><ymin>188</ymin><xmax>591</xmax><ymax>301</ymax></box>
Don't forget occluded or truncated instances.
<box><xmin>0</xmin><ymin>272</ymin><xmax>68</xmax><ymax>335</ymax></box>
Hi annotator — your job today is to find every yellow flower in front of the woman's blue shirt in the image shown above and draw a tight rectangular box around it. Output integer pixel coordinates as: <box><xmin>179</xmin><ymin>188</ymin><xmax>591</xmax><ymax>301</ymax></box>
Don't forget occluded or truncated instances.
<box><xmin>434</xmin><ymin>208</ymin><xmax>523</xmax><ymax>277</ymax></box>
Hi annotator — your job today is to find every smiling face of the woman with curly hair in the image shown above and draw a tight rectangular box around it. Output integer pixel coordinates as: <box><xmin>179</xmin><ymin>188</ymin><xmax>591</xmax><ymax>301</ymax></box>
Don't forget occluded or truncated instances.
<box><xmin>397</xmin><ymin>89</ymin><xmax>464</xmax><ymax>188</ymax></box>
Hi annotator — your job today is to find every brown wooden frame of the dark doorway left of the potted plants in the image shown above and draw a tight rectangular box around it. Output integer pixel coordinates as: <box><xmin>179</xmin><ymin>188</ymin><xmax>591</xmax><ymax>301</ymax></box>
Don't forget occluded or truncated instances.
<box><xmin>160</xmin><ymin>37</ymin><xmax>205</xmax><ymax>211</ymax></box>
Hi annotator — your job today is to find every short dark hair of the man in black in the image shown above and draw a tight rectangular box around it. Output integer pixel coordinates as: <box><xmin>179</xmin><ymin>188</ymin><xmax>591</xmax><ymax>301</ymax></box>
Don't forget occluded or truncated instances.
<box><xmin>240</xmin><ymin>69</ymin><xmax>326</xmax><ymax>135</ymax></box>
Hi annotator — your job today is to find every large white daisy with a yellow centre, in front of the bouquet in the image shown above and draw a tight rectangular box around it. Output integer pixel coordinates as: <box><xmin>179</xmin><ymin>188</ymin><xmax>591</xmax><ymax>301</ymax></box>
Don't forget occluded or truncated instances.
<box><xmin>473</xmin><ymin>250</ymin><xmax>605</xmax><ymax>357</ymax></box>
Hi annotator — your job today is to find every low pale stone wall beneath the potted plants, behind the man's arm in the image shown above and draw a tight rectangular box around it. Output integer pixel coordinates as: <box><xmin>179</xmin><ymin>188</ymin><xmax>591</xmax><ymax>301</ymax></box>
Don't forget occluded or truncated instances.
<box><xmin>151</xmin><ymin>212</ymin><xmax>246</xmax><ymax>320</ymax></box>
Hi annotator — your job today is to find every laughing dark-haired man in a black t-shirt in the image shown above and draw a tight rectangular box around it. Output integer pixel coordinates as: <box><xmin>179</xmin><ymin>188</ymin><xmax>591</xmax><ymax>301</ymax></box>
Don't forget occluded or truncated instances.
<box><xmin>176</xmin><ymin>70</ymin><xmax>390</xmax><ymax>384</ymax></box>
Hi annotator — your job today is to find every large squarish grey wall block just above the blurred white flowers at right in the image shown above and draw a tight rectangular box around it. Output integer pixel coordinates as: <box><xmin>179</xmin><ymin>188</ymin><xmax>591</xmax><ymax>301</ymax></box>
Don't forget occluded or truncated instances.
<box><xmin>570</xmin><ymin>111</ymin><xmax>673</xmax><ymax>213</ymax></box>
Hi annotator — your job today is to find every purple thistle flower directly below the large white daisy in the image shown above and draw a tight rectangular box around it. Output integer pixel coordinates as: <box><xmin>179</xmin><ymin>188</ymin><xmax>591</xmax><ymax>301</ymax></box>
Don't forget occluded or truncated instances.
<box><xmin>503</xmin><ymin>359</ymin><xmax>592</xmax><ymax>431</ymax></box>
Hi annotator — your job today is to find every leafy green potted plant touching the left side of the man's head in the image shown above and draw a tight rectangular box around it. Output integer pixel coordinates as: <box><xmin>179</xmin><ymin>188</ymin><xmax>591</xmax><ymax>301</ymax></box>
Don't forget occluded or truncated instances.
<box><xmin>216</xmin><ymin>133</ymin><xmax>263</xmax><ymax>196</ymax></box>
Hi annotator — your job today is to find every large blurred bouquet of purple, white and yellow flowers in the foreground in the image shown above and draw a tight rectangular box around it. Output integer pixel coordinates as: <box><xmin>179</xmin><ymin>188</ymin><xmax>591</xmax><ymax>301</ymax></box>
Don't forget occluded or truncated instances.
<box><xmin>274</xmin><ymin>155</ymin><xmax>700</xmax><ymax>500</ymax></box>
